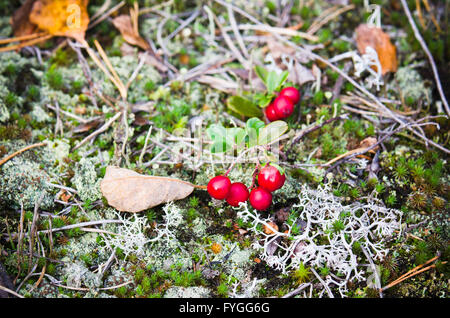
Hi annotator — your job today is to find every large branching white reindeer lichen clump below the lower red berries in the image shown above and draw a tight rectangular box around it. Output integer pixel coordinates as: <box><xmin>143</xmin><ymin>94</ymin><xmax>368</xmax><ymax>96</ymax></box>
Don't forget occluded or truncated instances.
<box><xmin>238</xmin><ymin>185</ymin><xmax>402</xmax><ymax>297</ymax></box>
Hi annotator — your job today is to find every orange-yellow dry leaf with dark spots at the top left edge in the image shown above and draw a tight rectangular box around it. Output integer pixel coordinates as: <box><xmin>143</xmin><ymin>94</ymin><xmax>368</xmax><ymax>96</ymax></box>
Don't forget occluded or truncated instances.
<box><xmin>29</xmin><ymin>0</ymin><xmax>89</xmax><ymax>42</ymax></box>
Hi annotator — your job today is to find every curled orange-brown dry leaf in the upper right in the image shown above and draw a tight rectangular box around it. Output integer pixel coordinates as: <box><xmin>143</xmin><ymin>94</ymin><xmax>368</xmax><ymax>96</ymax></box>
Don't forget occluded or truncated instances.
<box><xmin>355</xmin><ymin>24</ymin><xmax>397</xmax><ymax>75</ymax></box>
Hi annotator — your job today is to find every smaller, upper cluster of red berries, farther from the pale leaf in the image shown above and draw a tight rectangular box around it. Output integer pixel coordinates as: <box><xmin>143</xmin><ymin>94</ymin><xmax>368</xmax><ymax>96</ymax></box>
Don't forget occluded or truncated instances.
<box><xmin>264</xmin><ymin>86</ymin><xmax>300</xmax><ymax>121</ymax></box>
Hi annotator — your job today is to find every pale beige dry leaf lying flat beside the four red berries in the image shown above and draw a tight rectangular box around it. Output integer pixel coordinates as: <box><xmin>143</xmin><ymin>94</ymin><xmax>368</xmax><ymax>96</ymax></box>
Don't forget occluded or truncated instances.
<box><xmin>100</xmin><ymin>166</ymin><xmax>196</xmax><ymax>212</ymax></box>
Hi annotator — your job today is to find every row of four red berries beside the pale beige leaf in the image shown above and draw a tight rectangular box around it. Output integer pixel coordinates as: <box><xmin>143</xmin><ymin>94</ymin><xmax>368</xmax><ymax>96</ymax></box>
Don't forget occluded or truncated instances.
<box><xmin>207</xmin><ymin>164</ymin><xmax>286</xmax><ymax>211</ymax></box>
